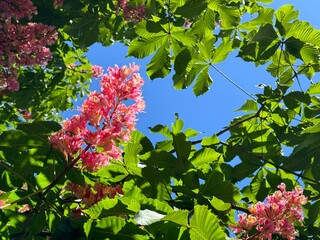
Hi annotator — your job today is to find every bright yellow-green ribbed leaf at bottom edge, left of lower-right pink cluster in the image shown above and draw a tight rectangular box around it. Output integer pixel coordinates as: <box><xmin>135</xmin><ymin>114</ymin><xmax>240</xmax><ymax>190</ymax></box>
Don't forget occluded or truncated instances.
<box><xmin>190</xmin><ymin>205</ymin><xmax>227</xmax><ymax>240</ymax></box>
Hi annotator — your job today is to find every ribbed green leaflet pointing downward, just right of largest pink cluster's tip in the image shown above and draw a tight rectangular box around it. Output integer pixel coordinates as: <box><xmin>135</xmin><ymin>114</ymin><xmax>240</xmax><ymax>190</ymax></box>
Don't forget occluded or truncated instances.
<box><xmin>147</xmin><ymin>41</ymin><xmax>171</xmax><ymax>80</ymax></box>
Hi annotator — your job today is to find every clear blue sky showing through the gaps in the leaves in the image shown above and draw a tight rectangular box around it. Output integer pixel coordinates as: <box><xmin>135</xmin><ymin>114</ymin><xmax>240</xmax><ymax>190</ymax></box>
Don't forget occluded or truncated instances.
<box><xmin>79</xmin><ymin>0</ymin><xmax>320</xmax><ymax>140</ymax></box>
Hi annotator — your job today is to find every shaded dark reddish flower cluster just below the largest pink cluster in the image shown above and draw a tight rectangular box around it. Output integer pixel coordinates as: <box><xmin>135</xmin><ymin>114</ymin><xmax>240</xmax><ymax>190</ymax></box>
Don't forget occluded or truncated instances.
<box><xmin>65</xmin><ymin>182</ymin><xmax>123</xmax><ymax>207</ymax></box>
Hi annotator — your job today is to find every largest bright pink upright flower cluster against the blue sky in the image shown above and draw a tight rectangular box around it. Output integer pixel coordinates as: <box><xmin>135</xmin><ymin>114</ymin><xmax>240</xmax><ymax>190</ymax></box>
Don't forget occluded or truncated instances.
<box><xmin>50</xmin><ymin>64</ymin><xmax>145</xmax><ymax>171</ymax></box>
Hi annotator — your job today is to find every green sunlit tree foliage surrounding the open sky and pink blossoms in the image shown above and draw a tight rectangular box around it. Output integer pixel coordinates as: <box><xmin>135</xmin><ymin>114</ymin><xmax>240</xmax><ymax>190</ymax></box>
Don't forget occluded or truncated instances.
<box><xmin>0</xmin><ymin>0</ymin><xmax>320</xmax><ymax>240</ymax></box>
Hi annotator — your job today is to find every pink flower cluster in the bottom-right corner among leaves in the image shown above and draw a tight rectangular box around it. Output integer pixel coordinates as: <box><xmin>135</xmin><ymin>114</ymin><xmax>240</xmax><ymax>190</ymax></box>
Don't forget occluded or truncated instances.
<box><xmin>231</xmin><ymin>183</ymin><xmax>307</xmax><ymax>240</ymax></box>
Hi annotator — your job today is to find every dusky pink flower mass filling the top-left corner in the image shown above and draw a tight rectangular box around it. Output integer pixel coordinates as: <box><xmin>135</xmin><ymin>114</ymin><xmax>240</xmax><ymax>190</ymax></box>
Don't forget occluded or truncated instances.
<box><xmin>0</xmin><ymin>0</ymin><xmax>57</xmax><ymax>92</ymax></box>
